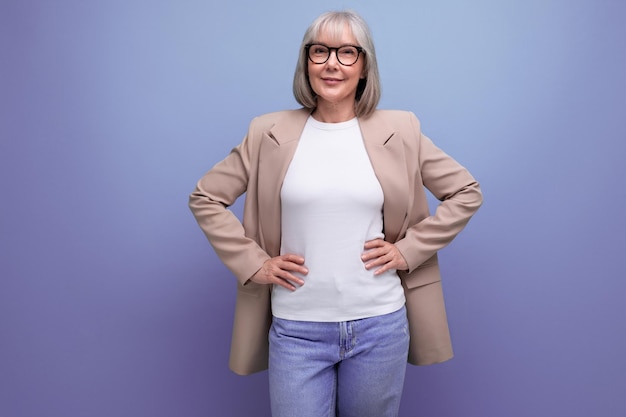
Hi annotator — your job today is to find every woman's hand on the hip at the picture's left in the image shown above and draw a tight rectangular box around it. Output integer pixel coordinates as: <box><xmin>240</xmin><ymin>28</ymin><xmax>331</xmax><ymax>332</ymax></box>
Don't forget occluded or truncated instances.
<box><xmin>250</xmin><ymin>253</ymin><xmax>309</xmax><ymax>291</ymax></box>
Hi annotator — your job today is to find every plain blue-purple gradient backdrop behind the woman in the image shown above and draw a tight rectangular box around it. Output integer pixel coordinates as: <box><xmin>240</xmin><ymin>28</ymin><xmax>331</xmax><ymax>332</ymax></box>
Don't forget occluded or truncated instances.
<box><xmin>0</xmin><ymin>0</ymin><xmax>626</xmax><ymax>417</ymax></box>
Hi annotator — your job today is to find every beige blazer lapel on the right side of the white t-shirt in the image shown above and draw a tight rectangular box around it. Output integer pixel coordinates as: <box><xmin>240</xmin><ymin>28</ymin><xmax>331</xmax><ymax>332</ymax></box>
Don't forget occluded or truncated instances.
<box><xmin>359</xmin><ymin>111</ymin><xmax>411</xmax><ymax>242</ymax></box>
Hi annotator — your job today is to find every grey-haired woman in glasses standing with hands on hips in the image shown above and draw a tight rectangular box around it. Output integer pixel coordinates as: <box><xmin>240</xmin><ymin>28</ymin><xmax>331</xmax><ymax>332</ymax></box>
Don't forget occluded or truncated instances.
<box><xmin>190</xmin><ymin>11</ymin><xmax>482</xmax><ymax>417</ymax></box>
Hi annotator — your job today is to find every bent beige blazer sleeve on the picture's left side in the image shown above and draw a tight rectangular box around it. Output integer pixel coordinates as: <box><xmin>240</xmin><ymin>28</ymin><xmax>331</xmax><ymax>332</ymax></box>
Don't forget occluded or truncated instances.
<box><xmin>189</xmin><ymin>120</ymin><xmax>270</xmax><ymax>285</ymax></box>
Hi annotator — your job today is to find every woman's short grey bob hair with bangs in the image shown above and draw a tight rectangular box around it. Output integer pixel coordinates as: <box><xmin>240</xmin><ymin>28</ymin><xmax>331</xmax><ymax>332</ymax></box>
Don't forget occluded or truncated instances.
<box><xmin>293</xmin><ymin>10</ymin><xmax>381</xmax><ymax>117</ymax></box>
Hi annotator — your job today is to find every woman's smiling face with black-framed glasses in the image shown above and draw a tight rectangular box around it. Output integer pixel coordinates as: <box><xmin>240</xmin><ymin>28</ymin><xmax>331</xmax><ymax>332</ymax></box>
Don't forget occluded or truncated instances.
<box><xmin>307</xmin><ymin>25</ymin><xmax>365</xmax><ymax>117</ymax></box>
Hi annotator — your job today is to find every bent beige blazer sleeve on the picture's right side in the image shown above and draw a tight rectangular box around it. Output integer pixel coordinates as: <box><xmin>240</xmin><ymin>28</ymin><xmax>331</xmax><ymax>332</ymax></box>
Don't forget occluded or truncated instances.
<box><xmin>396</xmin><ymin>113</ymin><xmax>483</xmax><ymax>273</ymax></box>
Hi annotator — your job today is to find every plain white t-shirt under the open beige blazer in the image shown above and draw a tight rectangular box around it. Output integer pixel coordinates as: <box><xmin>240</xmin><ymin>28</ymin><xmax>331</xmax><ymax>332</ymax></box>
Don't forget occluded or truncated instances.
<box><xmin>272</xmin><ymin>117</ymin><xmax>405</xmax><ymax>322</ymax></box>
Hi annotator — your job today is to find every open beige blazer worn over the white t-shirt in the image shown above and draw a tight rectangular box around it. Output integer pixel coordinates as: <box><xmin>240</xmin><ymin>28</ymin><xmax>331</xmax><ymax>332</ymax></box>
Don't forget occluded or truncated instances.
<box><xmin>189</xmin><ymin>109</ymin><xmax>482</xmax><ymax>375</ymax></box>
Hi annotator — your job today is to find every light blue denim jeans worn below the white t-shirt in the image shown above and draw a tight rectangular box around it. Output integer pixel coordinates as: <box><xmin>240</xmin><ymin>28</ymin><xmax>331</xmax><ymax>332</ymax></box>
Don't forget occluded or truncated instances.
<box><xmin>269</xmin><ymin>307</ymin><xmax>409</xmax><ymax>417</ymax></box>
